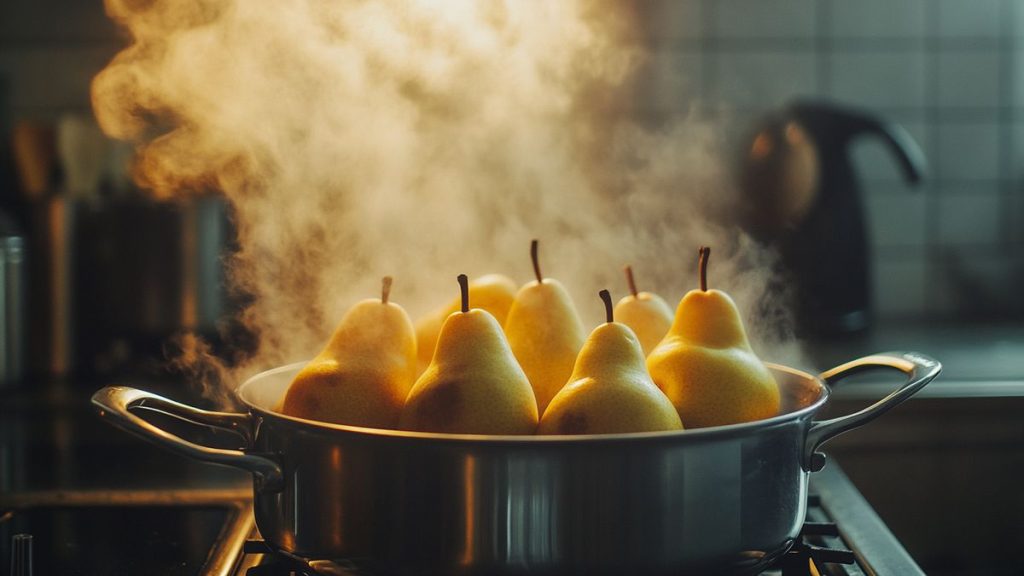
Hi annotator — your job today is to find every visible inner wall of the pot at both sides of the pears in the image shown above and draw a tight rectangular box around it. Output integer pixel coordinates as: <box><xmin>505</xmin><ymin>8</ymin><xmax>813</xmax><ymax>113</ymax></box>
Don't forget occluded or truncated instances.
<box><xmin>237</xmin><ymin>362</ymin><xmax>828</xmax><ymax>429</ymax></box>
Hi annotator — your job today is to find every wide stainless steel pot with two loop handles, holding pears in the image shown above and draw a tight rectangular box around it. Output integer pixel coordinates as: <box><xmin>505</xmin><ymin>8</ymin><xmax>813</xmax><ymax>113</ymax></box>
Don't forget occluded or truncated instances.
<box><xmin>92</xmin><ymin>353</ymin><xmax>941</xmax><ymax>574</ymax></box>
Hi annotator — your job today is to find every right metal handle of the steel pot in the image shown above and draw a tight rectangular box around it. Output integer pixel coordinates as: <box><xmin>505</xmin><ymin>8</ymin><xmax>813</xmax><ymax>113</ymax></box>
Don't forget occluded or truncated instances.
<box><xmin>804</xmin><ymin>352</ymin><xmax>942</xmax><ymax>471</ymax></box>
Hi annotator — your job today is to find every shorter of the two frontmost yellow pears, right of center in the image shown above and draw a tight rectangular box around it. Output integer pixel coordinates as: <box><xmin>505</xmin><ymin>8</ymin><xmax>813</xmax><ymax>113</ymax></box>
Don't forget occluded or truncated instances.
<box><xmin>537</xmin><ymin>290</ymin><xmax>683</xmax><ymax>435</ymax></box>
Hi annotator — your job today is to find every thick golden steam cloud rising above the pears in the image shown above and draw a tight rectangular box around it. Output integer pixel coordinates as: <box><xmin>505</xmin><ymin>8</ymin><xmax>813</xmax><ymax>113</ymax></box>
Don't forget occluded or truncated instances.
<box><xmin>92</xmin><ymin>0</ymin><xmax>796</xmax><ymax>399</ymax></box>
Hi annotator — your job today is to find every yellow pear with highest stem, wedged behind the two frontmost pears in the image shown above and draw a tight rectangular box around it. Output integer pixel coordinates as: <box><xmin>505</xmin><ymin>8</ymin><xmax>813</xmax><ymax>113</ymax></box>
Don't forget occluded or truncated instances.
<box><xmin>505</xmin><ymin>240</ymin><xmax>586</xmax><ymax>414</ymax></box>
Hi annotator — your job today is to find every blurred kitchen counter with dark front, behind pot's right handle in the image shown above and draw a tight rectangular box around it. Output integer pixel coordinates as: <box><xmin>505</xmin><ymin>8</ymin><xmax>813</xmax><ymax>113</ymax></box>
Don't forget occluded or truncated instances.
<box><xmin>807</xmin><ymin>315</ymin><xmax>1024</xmax><ymax>574</ymax></box>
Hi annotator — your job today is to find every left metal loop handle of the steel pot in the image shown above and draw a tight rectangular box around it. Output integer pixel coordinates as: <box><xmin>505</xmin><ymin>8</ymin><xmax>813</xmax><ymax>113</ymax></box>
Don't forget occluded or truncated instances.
<box><xmin>92</xmin><ymin>386</ymin><xmax>284</xmax><ymax>492</ymax></box>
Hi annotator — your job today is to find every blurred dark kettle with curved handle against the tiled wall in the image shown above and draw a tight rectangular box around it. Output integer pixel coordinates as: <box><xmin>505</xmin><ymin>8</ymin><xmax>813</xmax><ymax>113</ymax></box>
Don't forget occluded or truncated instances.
<box><xmin>741</xmin><ymin>100</ymin><xmax>926</xmax><ymax>335</ymax></box>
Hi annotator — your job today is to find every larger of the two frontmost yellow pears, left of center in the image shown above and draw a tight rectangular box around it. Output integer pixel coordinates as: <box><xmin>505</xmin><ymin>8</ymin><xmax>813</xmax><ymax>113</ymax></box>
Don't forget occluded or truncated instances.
<box><xmin>401</xmin><ymin>275</ymin><xmax>538</xmax><ymax>435</ymax></box>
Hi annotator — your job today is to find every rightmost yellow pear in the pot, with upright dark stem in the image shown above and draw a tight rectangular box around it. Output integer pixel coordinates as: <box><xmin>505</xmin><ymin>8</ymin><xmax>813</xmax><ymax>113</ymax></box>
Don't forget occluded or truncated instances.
<box><xmin>647</xmin><ymin>247</ymin><xmax>779</xmax><ymax>428</ymax></box>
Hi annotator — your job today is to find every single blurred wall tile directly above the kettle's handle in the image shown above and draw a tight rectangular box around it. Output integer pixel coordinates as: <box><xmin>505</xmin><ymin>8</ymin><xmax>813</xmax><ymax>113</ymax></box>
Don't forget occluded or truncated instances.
<box><xmin>828</xmin><ymin>49</ymin><xmax>927</xmax><ymax>109</ymax></box>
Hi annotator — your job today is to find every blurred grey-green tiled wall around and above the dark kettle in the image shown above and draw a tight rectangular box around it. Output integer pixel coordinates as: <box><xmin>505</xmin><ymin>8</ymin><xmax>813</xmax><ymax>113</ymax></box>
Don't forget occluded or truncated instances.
<box><xmin>622</xmin><ymin>0</ymin><xmax>1024</xmax><ymax>323</ymax></box>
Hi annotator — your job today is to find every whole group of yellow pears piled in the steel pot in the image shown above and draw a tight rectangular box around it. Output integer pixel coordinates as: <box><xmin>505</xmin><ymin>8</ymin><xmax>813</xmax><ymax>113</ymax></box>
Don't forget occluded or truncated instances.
<box><xmin>279</xmin><ymin>240</ymin><xmax>779</xmax><ymax>435</ymax></box>
